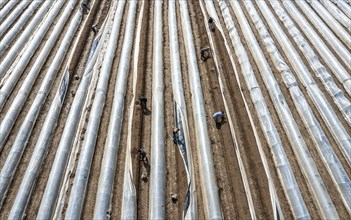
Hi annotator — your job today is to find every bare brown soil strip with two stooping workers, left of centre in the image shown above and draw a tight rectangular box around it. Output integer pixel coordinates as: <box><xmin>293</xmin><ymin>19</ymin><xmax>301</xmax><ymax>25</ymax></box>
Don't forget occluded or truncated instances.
<box><xmin>132</xmin><ymin>1</ymin><xmax>154</xmax><ymax>219</ymax></box>
